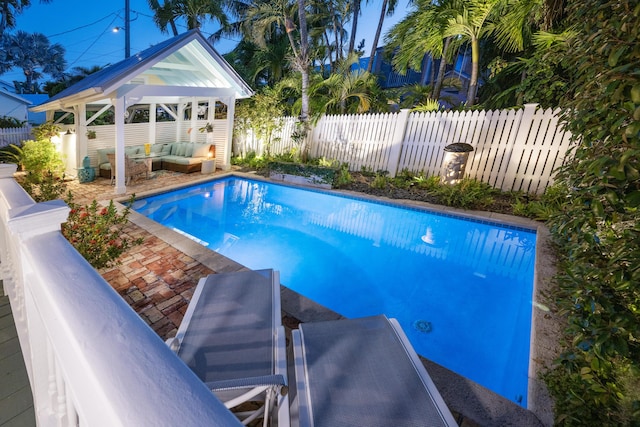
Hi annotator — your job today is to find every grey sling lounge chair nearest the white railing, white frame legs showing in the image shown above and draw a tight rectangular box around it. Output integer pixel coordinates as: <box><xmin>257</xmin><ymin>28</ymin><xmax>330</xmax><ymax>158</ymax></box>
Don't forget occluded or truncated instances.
<box><xmin>167</xmin><ymin>270</ymin><xmax>289</xmax><ymax>426</ymax></box>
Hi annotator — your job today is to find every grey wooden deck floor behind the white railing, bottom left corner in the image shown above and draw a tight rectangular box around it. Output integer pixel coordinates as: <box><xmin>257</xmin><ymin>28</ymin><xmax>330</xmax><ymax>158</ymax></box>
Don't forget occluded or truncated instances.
<box><xmin>0</xmin><ymin>285</ymin><xmax>36</xmax><ymax>427</ymax></box>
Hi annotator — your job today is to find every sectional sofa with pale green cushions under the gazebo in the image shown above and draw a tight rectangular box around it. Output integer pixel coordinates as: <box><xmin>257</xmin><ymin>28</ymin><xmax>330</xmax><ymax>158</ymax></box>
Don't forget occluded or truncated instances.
<box><xmin>97</xmin><ymin>142</ymin><xmax>215</xmax><ymax>178</ymax></box>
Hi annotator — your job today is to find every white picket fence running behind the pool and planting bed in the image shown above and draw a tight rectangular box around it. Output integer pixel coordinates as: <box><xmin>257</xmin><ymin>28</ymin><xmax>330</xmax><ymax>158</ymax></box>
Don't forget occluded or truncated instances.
<box><xmin>234</xmin><ymin>104</ymin><xmax>571</xmax><ymax>193</ymax></box>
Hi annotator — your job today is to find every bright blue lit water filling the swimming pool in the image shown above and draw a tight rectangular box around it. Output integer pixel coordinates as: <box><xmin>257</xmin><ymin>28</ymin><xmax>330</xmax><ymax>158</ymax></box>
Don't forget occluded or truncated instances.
<box><xmin>134</xmin><ymin>177</ymin><xmax>536</xmax><ymax>406</ymax></box>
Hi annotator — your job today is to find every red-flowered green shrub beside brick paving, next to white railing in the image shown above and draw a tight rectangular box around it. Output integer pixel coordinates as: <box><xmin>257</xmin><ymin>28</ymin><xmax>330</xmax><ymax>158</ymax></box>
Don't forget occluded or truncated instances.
<box><xmin>62</xmin><ymin>192</ymin><xmax>143</xmax><ymax>269</ymax></box>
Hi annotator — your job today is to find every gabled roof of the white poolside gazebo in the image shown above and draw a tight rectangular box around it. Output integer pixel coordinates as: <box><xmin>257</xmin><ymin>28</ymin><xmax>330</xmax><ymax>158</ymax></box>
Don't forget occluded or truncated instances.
<box><xmin>31</xmin><ymin>30</ymin><xmax>253</xmax><ymax>112</ymax></box>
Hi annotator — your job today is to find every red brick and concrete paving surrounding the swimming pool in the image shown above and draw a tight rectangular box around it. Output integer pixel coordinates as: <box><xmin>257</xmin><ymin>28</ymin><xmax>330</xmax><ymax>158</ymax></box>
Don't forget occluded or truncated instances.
<box><xmin>71</xmin><ymin>172</ymin><xmax>560</xmax><ymax>426</ymax></box>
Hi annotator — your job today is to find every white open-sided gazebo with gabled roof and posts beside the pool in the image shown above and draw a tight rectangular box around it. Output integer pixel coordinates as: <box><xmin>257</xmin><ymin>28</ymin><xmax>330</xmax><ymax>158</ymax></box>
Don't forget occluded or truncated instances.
<box><xmin>31</xmin><ymin>30</ymin><xmax>253</xmax><ymax>194</ymax></box>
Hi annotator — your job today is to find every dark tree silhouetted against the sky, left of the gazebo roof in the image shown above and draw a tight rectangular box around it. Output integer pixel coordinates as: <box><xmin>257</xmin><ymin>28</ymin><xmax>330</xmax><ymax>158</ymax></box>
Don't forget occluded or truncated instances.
<box><xmin>7</xmin><ymin>31</ymin><xmax>67</xmax><ymax>93</ymax></box>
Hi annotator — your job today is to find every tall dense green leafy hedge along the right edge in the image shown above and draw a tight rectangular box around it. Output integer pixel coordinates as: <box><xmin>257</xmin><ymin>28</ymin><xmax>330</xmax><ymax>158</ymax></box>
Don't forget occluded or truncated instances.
<box><xmin>546</xmin><ymin>0</ymin><xmax>640</xmax><ymax>426</ymax></box>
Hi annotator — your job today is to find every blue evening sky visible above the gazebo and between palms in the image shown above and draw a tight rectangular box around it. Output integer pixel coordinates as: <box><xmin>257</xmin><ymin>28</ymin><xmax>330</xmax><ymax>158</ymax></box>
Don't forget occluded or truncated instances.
<box><xmin>0</xmin><ymin>0</ymin><xmax>406</xmax><ymax>83</ymax></box>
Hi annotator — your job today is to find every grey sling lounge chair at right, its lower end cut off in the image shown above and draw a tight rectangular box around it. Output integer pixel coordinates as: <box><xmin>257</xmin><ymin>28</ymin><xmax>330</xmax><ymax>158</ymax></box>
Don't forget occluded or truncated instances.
<box><xmin>292</xmin><ymin>315</ymin><xmax>457</xmax><ymax>427</ymax></box>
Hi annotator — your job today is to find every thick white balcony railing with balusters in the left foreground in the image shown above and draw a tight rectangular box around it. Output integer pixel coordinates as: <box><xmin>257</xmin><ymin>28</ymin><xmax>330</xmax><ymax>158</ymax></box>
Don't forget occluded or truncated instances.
<box><xmin>0</xmin><ymin>165</ymin><xmax>239</xmax><ymax>426</ymax></box>
